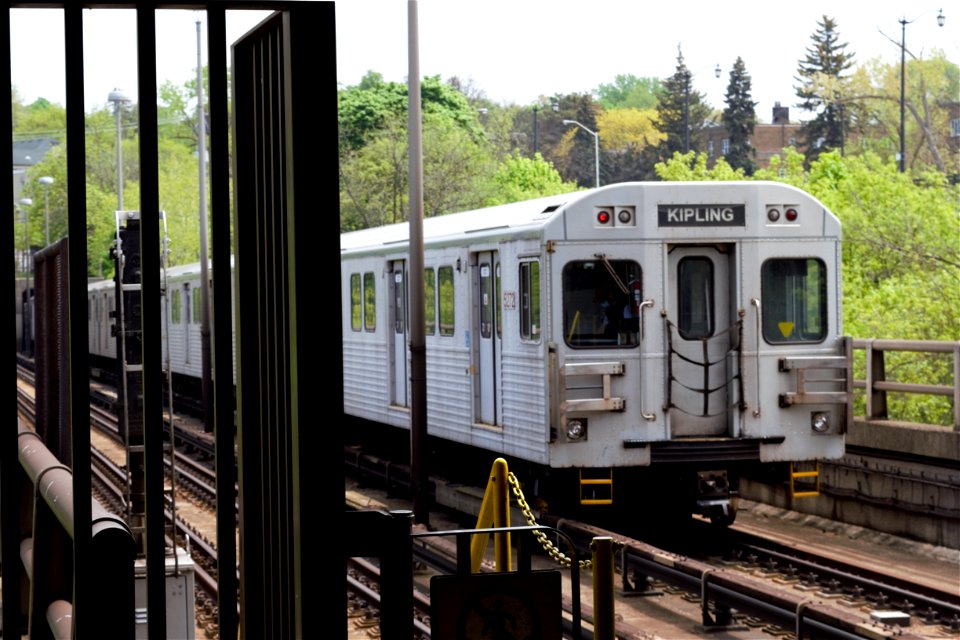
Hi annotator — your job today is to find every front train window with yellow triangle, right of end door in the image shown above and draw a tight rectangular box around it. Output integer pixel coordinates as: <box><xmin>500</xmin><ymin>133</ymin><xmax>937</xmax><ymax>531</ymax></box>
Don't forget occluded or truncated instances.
<box><xmin>760</xmin><ymin>258</ymin><xmax>827</xmax><ymax>344</ymax></box>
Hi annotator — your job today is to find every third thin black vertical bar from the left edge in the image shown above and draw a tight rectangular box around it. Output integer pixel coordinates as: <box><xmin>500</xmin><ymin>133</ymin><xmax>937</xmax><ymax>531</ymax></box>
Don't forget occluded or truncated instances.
<box><xmin>136</xmin><ymin>4</ymin><xmax>167</xmax><ymax>640</ymax></box>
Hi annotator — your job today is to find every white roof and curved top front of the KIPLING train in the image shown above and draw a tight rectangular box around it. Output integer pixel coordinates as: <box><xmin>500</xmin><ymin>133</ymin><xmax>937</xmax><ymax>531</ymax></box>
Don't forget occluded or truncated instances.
<box><xmin>340</xmin><ymin>180</ymin><xmax>840</xmax><ymax>256</ymax></box>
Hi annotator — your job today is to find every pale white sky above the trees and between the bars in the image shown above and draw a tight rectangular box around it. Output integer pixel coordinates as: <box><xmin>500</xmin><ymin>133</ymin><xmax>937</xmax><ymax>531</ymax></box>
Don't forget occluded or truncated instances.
<box><xmin>11</xmin><ymin>0</ymin><xmax>960</xmax><ymax>122</ymax></box>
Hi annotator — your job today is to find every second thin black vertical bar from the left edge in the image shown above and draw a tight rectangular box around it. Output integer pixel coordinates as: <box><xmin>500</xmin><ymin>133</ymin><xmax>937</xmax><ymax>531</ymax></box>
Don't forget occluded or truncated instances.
<box><xmin>63</xmin><ymin>4</ymin><xmax>97</xmax><ymax>638</ymax></box>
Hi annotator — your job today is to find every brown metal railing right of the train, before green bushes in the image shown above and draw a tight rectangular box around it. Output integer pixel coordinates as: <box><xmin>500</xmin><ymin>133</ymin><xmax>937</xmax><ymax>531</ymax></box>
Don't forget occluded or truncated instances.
<box><xmin>853</xmin><ymin>338</ymin><xmax>960</xmax><ymax>431</ymax></box>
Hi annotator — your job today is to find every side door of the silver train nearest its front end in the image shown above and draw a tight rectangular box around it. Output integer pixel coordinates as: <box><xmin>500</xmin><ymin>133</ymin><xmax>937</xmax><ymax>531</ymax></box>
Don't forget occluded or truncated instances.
<box><xmin>474</xmin><ymin>251</ymin><xmax>503</xmax><ymax>425</ymax></box>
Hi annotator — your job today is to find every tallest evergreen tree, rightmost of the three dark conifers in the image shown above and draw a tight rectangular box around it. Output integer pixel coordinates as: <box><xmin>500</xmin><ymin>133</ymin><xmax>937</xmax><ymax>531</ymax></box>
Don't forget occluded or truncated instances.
<box><xmin>794</xmin><ymin>16</ymin><xmax>854</xmax><ymax>161</ymax></box>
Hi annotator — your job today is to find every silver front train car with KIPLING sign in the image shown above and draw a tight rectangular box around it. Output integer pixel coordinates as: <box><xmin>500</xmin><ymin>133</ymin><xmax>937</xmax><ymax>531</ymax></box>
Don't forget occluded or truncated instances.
<box><xmin>340</xmin><ymin>181</ymin><xmax>852</xmax><ymax>524</ymax></box>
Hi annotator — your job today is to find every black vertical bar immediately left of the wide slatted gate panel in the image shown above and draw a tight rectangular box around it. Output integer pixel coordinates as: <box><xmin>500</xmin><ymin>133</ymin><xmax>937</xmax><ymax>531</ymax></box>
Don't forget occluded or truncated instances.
<box><xmin>207</xmin><ymin>10</ymin><xmax>237</xmax><ymax>638</ymax></box>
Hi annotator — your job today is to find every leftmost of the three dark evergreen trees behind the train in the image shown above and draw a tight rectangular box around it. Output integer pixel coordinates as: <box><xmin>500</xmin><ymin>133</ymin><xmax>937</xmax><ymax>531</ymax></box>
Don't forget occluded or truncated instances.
<box><xmin>657</xmin><ymin>47</ymin><xmax>710</xmax><ymax>160</ymax></box>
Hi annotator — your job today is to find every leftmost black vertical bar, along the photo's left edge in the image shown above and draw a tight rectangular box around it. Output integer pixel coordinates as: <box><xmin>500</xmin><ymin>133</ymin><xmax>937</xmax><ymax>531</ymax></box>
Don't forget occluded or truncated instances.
<box><xmin>0</xmin><ymin>3</ymin><xmax>26</xmax><ymax>636</ymax></box>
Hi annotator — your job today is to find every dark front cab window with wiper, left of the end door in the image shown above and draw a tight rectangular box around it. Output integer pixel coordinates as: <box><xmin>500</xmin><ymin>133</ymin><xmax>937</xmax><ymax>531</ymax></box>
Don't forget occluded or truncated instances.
<box><xmin>563</xmin><ymin>259</ymin><xmax>642</xmax><ymax>349</ymax></box>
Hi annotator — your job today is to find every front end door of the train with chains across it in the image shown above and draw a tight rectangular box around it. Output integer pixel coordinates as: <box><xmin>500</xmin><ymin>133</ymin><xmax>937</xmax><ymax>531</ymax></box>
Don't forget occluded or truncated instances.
<box><xmin>665</xmin><ymin>244</ymin><xmax>740</xmax><ymax>437</ymax></box>
